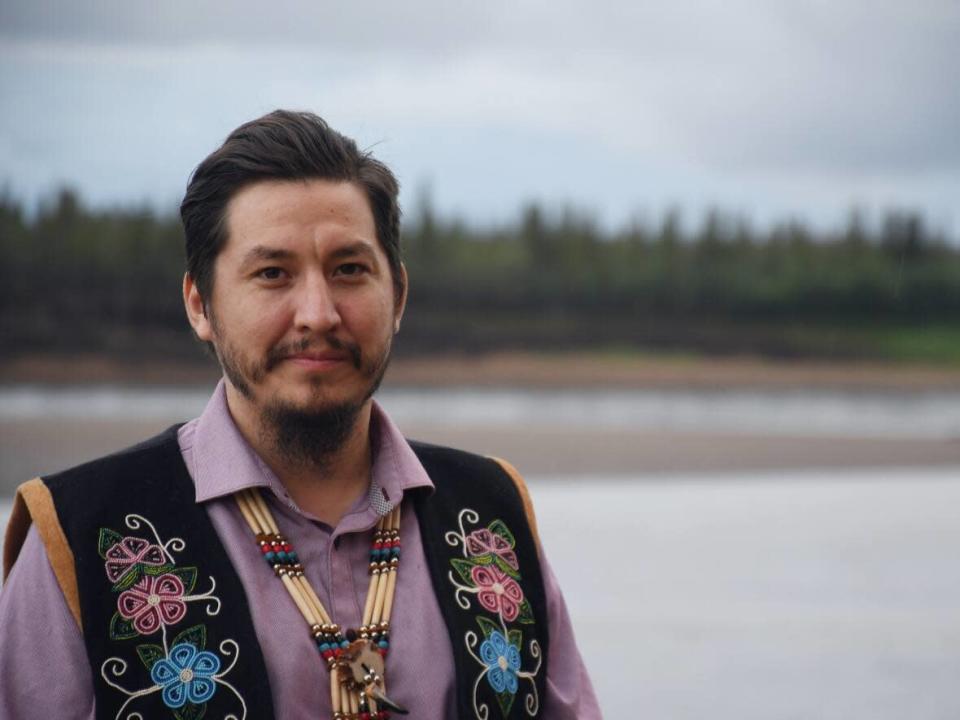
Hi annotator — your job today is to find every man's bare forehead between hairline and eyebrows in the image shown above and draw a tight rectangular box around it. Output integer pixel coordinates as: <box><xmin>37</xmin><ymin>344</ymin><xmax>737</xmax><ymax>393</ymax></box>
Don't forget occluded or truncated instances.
<box><xmin>221</xmin><ymin>180</ymin><xmax>382</xmax><ymax>253</ymax></box>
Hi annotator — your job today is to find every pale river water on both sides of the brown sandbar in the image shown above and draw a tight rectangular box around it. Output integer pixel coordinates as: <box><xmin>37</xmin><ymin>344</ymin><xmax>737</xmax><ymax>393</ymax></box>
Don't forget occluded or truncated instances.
<box><xmin>0</xmin><ymin>388</ymin><xmax>960</xmax><ymax>720</ymax></box>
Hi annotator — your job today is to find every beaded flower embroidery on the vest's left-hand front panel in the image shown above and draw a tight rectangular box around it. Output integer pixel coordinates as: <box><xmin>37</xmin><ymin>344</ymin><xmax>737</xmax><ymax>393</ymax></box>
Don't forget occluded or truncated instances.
<box><xmin>97</xmin><ymin>515</ymin><xmax>247</xmax><ymax>720</ymax></box>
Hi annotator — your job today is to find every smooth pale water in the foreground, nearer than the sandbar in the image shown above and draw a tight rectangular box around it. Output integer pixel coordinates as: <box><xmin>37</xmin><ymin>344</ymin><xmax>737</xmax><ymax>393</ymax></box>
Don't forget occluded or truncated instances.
<box><xmin>0</xmin><ymin>468</ymin><xmax>960</xmax><ymax>720</ymax></box>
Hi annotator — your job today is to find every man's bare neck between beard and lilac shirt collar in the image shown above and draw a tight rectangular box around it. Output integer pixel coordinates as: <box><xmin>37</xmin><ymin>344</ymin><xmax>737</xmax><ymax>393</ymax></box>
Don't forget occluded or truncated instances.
<box><xmin>227</xmin><ymin>383</ymin><xmax>372</xmax><ymax>527</ymax></box>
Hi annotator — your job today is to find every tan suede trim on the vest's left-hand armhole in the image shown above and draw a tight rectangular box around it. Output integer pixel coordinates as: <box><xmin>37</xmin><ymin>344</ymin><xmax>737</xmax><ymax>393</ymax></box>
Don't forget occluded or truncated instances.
<box><xmin>3</xmin><ymin>478</ymin><xmax>83</xmax><ymax>630</ymax></box>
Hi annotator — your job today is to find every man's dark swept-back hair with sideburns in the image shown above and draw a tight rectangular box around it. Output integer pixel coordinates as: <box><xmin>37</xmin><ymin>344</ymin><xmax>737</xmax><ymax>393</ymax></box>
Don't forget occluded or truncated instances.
<box><xmin>180</xmin><ymin>110</ymin><xmax>404</xmax><ymax>304</ymax></box>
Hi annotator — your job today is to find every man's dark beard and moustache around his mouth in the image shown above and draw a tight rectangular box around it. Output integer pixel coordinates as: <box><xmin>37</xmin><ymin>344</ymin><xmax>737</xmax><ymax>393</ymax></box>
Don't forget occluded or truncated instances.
<box><xmin>210</xmin><ymin>313</ymin><xmax>391</xmax><ymax>469</ymax></box>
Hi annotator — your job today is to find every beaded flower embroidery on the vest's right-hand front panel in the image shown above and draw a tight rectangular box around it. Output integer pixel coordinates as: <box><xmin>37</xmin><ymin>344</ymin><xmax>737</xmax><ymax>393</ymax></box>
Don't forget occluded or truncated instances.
<box><xmin>444</xmin><ymin>508</ymin><xmax>542</xmax><ymax>720</ymax></box>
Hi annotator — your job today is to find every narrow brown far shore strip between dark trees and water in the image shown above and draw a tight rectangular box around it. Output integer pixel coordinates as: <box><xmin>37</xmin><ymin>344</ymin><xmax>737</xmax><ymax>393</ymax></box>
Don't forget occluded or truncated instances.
<box><xmin>0</xmin><ymin>352</ymin><xmax>960</xmax><ymax>392</ymax></box>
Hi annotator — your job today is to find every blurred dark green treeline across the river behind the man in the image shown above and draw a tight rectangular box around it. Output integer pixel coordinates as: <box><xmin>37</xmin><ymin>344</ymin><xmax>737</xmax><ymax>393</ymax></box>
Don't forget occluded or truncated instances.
<box><xmin>0</xmin><ymin>190</ymin><xmax>960</xmax><ymax>361</ymax></box>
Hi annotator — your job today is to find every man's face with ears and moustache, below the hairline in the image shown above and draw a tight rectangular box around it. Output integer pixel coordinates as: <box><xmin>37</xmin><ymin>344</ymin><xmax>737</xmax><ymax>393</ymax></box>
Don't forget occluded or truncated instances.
<box><xmin>185</xmin><ymin>180</ymin><xmax>405</xmax><ymax>428</ymax></box>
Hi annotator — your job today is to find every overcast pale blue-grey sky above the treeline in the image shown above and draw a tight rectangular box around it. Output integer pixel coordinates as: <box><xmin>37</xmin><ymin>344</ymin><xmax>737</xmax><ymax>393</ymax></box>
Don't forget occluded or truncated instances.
<box><xmin>0</xmin><ymin>0</ymin><xmax>960</xmax><ymax>239</ymax></box>
